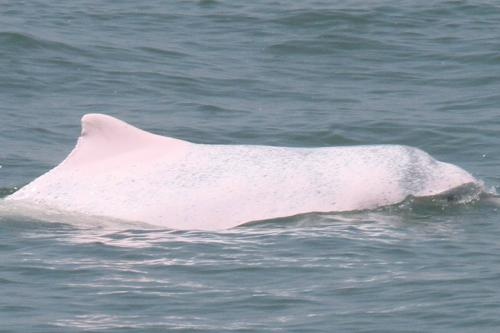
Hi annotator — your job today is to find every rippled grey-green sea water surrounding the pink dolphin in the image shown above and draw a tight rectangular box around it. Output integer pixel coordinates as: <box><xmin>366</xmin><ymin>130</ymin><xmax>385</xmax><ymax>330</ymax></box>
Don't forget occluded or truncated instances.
<box><xmin>0</xmin><ymin>0</ymin><xmax>500</xmax><ymax>332</ymax></box>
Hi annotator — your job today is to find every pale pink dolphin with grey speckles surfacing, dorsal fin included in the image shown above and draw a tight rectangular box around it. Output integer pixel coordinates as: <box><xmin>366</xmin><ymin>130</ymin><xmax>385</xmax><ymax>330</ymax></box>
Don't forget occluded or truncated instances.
<box><xmin>6</xmin><ymin>114</ymin><xmax>479</xmax><ymax>230</ymax></box>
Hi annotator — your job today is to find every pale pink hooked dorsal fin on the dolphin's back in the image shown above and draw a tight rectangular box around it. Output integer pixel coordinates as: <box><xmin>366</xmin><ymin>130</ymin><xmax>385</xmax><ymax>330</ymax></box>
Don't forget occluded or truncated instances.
<box><xmin>61</xmin><ymin>113</ymin><xmax>188</xmax><ymax>167</ymax></box>
